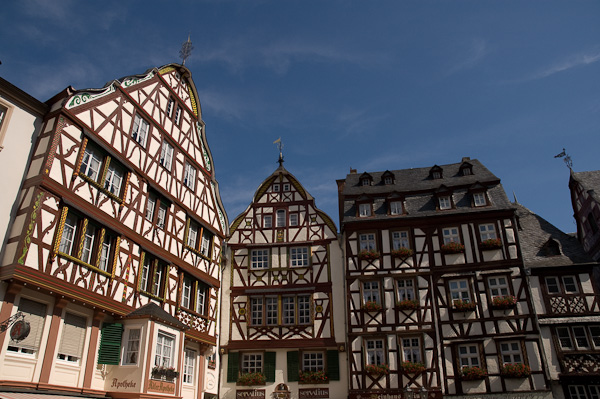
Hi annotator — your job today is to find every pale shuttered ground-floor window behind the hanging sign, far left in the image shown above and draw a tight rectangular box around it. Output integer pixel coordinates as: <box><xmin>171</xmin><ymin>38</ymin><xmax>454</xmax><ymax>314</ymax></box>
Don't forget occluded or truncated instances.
<box><xmin>7</xmin><ymin>297</ymin><xmax>47</xmax><ymax>356</ymax></box>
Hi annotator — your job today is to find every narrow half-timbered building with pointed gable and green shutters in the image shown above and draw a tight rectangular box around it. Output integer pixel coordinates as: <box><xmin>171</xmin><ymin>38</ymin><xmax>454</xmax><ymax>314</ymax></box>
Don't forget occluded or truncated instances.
<box><xmin>221</xmin><ymin>159</ymin><xmax>347</xmax><ymax>398</ymax></box>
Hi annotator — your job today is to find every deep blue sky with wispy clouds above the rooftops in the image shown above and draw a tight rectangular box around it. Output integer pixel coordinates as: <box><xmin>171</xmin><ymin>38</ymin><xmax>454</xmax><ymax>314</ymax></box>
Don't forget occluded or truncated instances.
<box><xmin>0</xmin><ymin>0</ymin><xmax>600</xmax><ymax>232</ymax></box>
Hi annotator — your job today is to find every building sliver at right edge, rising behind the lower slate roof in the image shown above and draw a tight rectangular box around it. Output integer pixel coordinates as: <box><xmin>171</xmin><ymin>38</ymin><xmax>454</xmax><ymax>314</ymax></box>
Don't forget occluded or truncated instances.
<box><xmin>569</xmin><ymin>169</ymin><xmax>600</xmax><ymax>261</ymax></box>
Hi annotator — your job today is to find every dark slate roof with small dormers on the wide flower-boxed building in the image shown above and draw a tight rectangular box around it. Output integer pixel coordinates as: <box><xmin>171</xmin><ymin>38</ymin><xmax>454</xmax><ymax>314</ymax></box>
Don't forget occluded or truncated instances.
<box><xmin>341</xmin><ymin>158</ymin><xmax>514</xmax><ymax>222</ymax></box>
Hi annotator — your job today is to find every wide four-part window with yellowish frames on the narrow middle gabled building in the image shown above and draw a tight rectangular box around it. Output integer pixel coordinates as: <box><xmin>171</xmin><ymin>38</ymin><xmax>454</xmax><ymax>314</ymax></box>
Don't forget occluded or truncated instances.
<box><xmin>250</xmin><ymin>295</ymin><xmax>311</xmax><ymax>326</ymax></box>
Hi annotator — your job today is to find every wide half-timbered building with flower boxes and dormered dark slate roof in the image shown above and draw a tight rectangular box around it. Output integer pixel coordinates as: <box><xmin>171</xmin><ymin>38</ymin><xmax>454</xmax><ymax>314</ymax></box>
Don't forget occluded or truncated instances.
<box><xmin>338</xmin><ymin>158</ymin><xmax>549</xmax><ymax>399</ymax></box>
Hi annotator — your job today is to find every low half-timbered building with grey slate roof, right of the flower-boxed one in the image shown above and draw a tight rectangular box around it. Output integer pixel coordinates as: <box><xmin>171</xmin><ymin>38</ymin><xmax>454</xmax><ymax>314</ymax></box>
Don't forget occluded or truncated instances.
<box><xmin>517</xmin><ymin>205</ymin><xmax>600</xmax><ymax>399</ymax></box>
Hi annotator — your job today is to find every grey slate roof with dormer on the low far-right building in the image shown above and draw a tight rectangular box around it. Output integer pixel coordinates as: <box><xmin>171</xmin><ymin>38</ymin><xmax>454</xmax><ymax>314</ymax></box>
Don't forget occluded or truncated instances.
<box><xmin>515</xmin><ymin>203</ymin><xmax>597</xmax><ymax>268</ymax></box>
